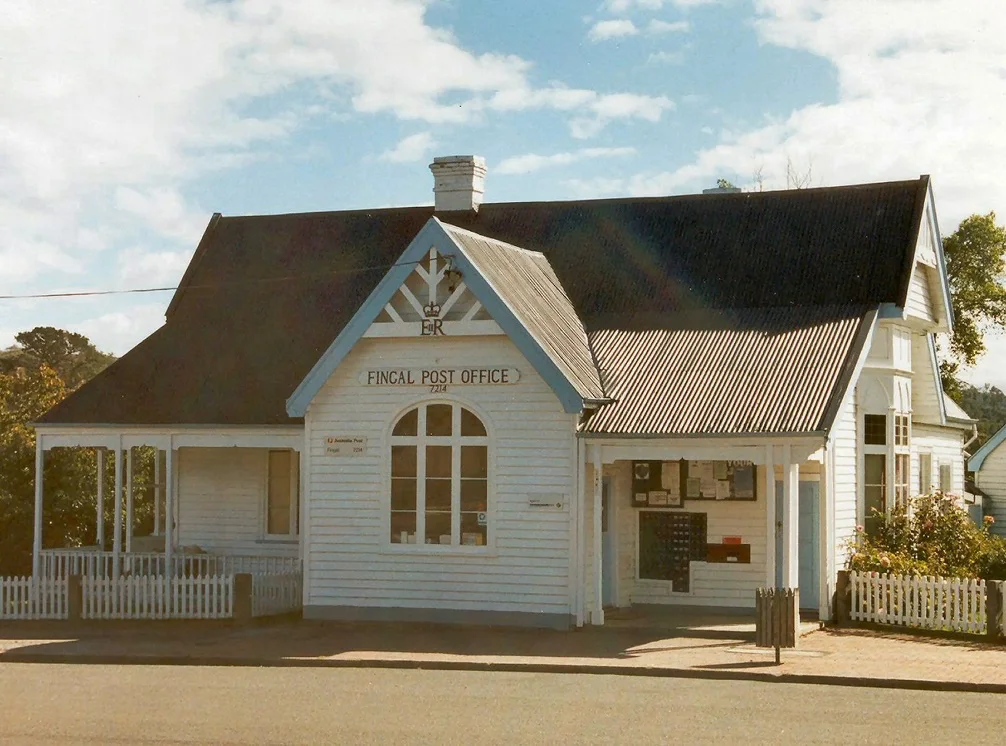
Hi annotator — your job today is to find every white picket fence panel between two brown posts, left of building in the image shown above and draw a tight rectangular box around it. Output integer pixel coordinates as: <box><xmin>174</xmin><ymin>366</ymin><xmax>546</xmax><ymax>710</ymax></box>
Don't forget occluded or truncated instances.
<box><xmin>81</xmin><ymin>575</ymin><xmax>234</xmax><ymax>619</ymax></box>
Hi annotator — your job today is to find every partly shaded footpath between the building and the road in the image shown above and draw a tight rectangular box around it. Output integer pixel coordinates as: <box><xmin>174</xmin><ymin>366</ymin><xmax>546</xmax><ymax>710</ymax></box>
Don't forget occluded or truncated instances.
<box><xmin>0</xmin><ymin>620</ymin><xmax>1006</xmax><ymax>694</ymax></box>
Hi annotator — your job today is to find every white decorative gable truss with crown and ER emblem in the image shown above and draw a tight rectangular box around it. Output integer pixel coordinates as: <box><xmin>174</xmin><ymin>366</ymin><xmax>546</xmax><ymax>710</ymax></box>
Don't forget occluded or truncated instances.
<box><xmin>363</xmin><ymin>247</ymin><xmax>503</xmax><ymax>337</ymax></box>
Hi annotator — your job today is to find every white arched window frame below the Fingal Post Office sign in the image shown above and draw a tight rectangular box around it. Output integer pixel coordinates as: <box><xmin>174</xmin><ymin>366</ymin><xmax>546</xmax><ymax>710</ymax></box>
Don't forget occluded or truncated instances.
<box><xmin>382</xmin><ymin>399</ymin><xmax>496</xmax><ymax>555</ymax></box>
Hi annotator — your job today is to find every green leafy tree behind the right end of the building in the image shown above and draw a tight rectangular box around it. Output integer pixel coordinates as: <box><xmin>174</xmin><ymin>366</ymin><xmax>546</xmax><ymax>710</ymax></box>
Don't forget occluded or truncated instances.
<box><xmin>940</xmin><ymin>212</ymin><xmax>1006</xmax><ymax>402</ymax></box>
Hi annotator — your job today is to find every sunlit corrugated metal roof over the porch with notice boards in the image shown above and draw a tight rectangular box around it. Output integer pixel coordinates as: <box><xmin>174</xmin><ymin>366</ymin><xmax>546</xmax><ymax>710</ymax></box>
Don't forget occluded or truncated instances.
<box><xmin>584</xmin><ymin>307</ymin><xmax>875</xmax><ymax>436</ymax></box>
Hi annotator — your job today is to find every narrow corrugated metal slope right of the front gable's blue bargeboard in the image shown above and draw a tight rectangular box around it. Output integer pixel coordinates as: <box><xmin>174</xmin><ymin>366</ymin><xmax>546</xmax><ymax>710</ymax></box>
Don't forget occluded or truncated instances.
<box><xmin>441</xmin><ymin>222</ymin><xmax>605</xmax><ymax>399</ymax></box>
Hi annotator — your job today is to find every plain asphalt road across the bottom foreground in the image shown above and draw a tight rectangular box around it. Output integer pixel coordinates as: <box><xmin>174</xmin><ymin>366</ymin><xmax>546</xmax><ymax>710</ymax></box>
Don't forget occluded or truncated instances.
<box><xmin>0</xmin><ymin>664</ymin><xmax>1006</xmax><ymax>746</ymax></box>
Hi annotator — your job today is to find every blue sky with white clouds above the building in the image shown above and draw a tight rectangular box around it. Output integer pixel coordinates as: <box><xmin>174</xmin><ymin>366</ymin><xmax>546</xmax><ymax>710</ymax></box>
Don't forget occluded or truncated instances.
<box><xmin>0</xmin><ymin>0</ymin><xmax>1006</xmax><ymax>389</ymax></box>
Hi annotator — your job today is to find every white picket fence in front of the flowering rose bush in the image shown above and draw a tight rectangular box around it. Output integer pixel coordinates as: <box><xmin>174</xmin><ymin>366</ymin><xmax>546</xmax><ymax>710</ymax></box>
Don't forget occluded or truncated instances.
<box><xmin>849</xmin><ymin>570</ymin><xmax>987</xmax><ymax>634</ymax></box>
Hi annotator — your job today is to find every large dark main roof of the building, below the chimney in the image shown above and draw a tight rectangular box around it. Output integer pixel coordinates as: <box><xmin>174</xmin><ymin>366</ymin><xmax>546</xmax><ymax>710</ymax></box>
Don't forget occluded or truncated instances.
<box><xmin>40</xmin><ymin>177</ymin><xmax>929</xmax><ymax>424</ymax></box>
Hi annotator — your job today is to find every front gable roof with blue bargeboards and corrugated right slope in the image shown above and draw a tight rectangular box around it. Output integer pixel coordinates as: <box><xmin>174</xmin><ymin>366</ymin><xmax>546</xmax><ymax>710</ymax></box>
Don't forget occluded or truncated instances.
<box><xmin>287</xmin><ymin>217</ymin><xmax>605</xmax><ymax>417</ymax></box>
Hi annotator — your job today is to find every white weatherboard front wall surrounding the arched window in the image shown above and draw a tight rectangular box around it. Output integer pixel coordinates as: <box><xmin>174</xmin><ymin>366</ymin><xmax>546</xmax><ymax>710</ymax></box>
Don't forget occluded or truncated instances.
<box><xmin>306</xmin><ymin>336</ymin><xmax>574</xmax><ymax>618</ymax></box>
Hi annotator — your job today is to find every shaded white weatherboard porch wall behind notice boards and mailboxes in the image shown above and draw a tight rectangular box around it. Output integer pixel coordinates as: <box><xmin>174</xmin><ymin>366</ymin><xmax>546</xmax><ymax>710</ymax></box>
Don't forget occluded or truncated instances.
<box><xmin>612</xmin><ymin>453</ymin><xmax>766</xmax><ymax>608</ymax></box>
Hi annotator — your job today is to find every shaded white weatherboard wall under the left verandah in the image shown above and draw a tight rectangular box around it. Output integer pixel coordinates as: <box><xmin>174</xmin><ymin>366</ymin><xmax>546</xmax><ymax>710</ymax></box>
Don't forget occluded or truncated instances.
<box><xmin>178</xmin><ymin>448</ymin><xmax>298</xmax><ymax>557</ymax></box>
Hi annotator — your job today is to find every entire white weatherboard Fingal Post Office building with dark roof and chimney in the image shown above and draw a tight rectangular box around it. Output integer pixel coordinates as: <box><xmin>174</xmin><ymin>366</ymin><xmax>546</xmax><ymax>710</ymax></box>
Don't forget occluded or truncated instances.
<box><xmin>35</xmin><ymin>157</ymin><xmax>974</xmax><ymax>627</ymax></box>
